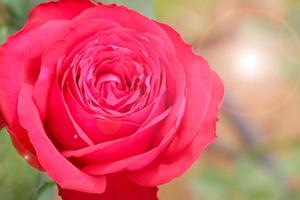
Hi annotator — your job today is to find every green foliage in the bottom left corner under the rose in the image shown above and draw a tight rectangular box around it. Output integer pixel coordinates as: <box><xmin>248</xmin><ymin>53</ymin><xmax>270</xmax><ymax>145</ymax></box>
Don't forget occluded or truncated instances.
<box><xmin>0</xmin><ymin>129</ymin><xmax>55</xmax><ymax>200</ymax></box>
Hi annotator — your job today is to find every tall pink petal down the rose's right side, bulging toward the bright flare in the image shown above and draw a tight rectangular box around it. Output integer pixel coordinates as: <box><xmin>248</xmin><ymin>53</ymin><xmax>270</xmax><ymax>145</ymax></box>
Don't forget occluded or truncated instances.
<box><xmin>161</xmin><ymin>24</ymin><xmax>224</xmax><ymax>153</ymax></box>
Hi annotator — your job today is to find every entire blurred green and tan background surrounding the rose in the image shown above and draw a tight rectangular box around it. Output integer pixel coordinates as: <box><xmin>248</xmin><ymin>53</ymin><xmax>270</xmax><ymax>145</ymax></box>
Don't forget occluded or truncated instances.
<box><xmin>0</xmin><ymin>0</ymin><xmax>300</xmax><ymax>200</ymax></box>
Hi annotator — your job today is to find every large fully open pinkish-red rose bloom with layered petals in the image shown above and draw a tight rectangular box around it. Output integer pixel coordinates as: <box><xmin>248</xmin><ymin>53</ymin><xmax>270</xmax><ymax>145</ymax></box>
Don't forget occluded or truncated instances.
<box><xmin>0</xmin><ymin>0</ymin><xmax>224</xmax><ymax>200</ymax></box>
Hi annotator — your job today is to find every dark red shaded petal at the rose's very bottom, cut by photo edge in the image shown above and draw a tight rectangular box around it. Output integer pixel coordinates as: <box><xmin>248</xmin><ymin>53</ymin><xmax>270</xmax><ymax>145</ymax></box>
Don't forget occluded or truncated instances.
<box><xmin>59</xmin><ymin>175</ymin><xmax>158</xmax><ymax>200</ymax></box>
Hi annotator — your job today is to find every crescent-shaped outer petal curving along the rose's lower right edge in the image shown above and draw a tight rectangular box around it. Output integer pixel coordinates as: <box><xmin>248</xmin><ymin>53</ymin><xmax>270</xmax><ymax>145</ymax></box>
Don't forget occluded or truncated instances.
<box><xmin>128</xmin><ymin>72</ymin><xmax>224</xmax><ymax>186</ymax></box>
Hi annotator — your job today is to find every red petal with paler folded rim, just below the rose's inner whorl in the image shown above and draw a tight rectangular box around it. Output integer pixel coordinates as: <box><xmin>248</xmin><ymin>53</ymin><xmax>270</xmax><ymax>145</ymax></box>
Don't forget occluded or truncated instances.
<box><xmin>59</xmin><ymin>94</ymin><xmax>171</xmax><ymax>168</ymax></box>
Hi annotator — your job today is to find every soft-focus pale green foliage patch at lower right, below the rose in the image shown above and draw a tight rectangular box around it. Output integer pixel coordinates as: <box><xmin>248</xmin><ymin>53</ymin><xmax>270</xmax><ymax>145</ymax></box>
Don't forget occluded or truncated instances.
<box><xmin>195</xmin><ymin>158</ymin><xmax>281</xmax><ymax>200</ymax></box>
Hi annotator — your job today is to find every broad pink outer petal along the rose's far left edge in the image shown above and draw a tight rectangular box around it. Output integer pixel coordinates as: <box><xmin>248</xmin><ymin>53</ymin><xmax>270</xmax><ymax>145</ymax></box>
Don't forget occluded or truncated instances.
<box><xmin>0</xmin><ymin>20</ymin><xmax>66</xmax><ymax>167</ymax></box>
